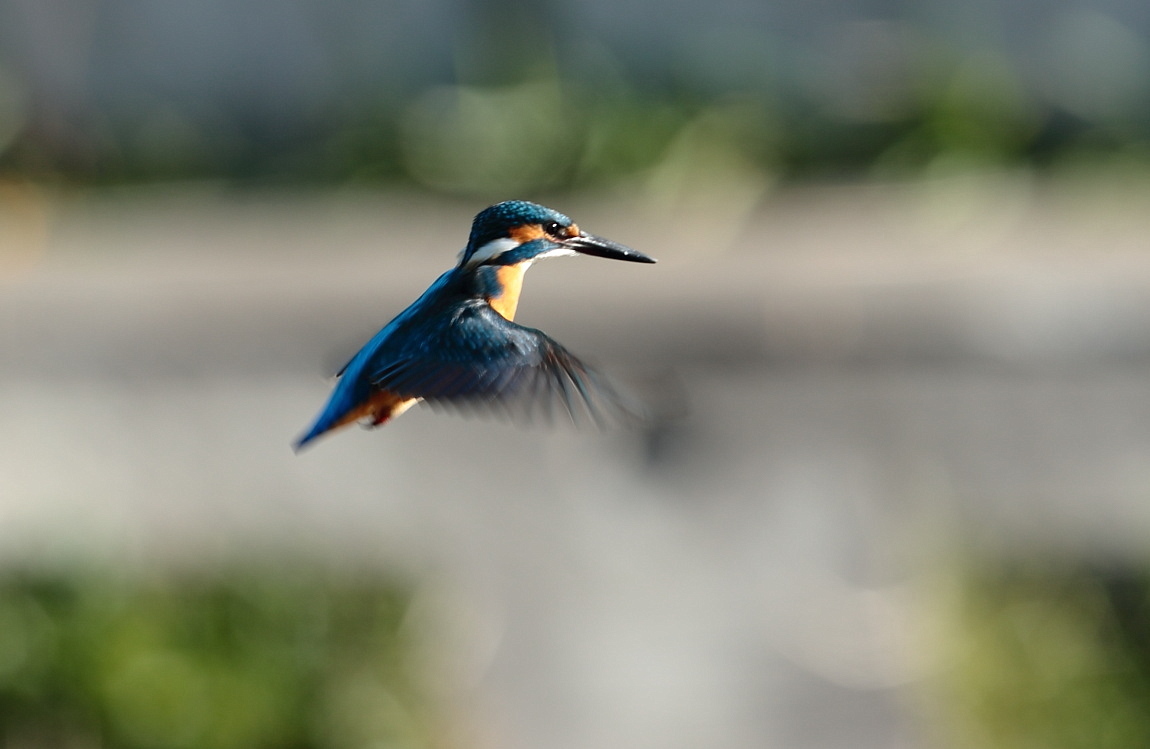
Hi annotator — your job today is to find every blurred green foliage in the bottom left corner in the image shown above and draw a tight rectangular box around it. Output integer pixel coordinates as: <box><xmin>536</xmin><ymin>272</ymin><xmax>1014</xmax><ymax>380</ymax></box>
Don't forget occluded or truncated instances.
<box><xmin>0</xmin><ymin>568</ymin><xmax>430</xmax><ymax>749</ymax></box>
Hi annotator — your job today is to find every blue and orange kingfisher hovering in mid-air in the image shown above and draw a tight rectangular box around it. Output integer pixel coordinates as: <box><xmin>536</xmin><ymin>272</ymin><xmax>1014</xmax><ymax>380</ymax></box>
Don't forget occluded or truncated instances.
<box><xmin>294</xmin><ymin>200</ymin><xmax>654</xmax><ymax>451</ymax></box>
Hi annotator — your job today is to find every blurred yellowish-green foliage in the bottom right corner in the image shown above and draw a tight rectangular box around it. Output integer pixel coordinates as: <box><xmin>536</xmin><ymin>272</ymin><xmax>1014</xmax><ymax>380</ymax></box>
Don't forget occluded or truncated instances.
<box><xmin>943</xmin><ymin>564</ymin><xmax>1150</xmax><ymax>749</ymax></box>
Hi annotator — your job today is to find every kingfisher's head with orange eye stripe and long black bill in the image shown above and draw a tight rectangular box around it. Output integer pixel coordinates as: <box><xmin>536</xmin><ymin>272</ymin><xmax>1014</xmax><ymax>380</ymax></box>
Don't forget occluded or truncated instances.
<box><xmin>459</xmin><ymin>200</ymin><xmax>654</xmax><ymax>268</ymax></box>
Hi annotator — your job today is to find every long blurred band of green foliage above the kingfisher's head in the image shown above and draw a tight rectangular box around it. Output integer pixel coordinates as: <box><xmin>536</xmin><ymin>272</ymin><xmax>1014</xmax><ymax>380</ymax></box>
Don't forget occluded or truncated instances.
<box><xmin>0</xmin><ymin>51</ymin><xmax>1131</xmax><ymax>192</ymax></box>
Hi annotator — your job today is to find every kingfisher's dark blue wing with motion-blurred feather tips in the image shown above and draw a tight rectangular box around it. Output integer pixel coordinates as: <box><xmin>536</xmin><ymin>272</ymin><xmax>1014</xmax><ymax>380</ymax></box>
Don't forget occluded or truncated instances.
<box><xmin>369</xmin><ymin>303</ymin><xmax>642</xmax><ymax>426</ymax></box>
